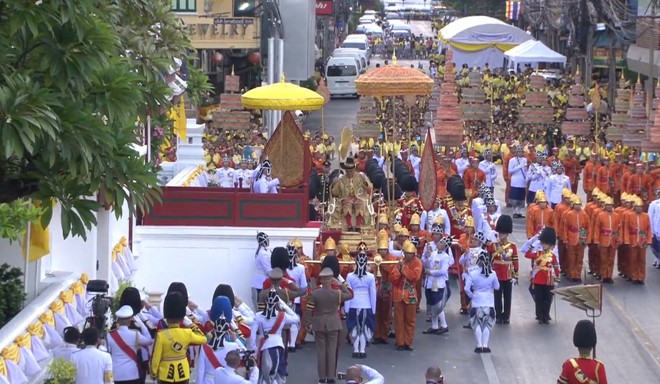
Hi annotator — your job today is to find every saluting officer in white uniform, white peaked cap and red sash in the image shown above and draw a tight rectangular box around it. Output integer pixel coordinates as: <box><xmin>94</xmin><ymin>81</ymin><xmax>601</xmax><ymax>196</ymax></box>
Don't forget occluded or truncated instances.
<box><xmin>107</xmin><ymin>305</ymin><xmax>153</xmax><ymax>384</ymax></box>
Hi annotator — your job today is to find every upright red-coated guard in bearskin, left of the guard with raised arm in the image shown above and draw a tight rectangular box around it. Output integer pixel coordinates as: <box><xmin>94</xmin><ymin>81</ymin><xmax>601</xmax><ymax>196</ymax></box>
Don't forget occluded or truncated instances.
<box><xmin>488</xmin><ymin>215</ymin><xmax>518</xmax><ymax>324</ymax></box>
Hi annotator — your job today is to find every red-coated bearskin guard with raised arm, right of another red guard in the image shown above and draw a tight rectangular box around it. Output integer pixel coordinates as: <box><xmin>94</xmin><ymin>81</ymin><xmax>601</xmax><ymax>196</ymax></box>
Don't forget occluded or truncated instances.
<box><xmin>523</xmin><ymin>227</ymin><xmax>559</xmax><ymax>324</ymax></box>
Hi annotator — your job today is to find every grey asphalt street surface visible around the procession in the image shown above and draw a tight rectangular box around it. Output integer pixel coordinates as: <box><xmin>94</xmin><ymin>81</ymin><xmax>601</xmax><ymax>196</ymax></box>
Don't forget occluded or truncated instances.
<box><xmin>296</xmin><ymin>18</ymin><xmax>660</xmax><ymax>384</ymax></box>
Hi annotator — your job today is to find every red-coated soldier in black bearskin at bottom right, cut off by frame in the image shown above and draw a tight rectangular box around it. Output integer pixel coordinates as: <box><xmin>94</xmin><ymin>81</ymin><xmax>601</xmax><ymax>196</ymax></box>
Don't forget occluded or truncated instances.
<box><xmin>557</xmin><ymin>320</ymin><xmax>607</xmax><ymax>384</ymax></box>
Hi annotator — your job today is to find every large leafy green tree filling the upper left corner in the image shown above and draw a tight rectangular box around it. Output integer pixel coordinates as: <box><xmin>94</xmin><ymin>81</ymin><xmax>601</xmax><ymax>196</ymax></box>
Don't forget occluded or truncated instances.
<box><xmin>0</xmin><ymin>0</ymin><xmax>196</xmax><ymax>238</ymax></box>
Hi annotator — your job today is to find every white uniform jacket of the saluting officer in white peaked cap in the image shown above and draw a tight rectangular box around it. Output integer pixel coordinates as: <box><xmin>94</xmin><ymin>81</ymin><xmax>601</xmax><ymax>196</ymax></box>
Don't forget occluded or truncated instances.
<box><xmin>106</xmin><ymin>324</ymin><xmax>153</xmax><ymax>381</ymax></box>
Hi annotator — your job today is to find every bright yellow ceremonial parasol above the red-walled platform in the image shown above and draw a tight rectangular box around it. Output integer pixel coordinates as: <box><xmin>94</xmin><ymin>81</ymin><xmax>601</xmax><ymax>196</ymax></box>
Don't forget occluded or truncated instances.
<box><xmin>241</xmin><ymin>76</ymin><xmax>325</xmax><ymax>111</ymax></box>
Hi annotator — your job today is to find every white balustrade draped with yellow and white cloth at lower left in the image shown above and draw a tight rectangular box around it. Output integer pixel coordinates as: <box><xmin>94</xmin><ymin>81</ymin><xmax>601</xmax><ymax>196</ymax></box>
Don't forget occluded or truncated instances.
<box><xmin>0</xmin><ymin>273</ymin><xmax>89</xmax><ymax>384</ymax></box>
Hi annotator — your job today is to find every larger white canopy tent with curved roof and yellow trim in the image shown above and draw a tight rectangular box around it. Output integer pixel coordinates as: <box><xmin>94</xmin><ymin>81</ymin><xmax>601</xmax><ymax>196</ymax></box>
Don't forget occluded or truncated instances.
<box><xmin>440</xmin><ymin>16</ymin><xmax>534</xmax><ymax>67</ymax></box>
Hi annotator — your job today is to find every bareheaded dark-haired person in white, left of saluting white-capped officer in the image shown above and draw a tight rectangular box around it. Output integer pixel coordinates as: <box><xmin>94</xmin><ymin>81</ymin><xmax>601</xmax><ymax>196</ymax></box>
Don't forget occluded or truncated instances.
<box><xmin>71</xmin><ymin>327</ymin><xmax>114</xmax><ymax>384</ymax></box>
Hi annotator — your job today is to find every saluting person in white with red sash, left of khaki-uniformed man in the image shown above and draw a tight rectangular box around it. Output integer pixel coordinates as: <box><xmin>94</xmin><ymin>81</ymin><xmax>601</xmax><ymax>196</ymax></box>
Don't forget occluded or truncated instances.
<box><xmin>249</xmin><ymin>290</ymin><xmax>300</xmax><ymax>384</ymax></box>
